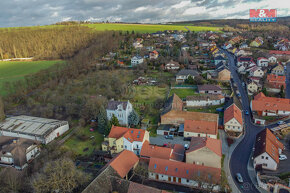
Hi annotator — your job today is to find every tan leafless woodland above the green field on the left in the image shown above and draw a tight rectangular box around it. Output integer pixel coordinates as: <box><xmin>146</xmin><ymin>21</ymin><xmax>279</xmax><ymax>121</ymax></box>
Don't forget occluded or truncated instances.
<box><xmin>0</xmin><ymin>26</ymin><xmax>98</xmax><ymax>59</ymax></box>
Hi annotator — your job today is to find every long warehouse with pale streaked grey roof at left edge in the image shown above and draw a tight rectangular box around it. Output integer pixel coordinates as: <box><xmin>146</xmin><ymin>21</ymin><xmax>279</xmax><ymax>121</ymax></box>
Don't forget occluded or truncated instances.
<box><xmin>0</xmin><ymin>115</ymin><xmax>68</xmax><ymax>137</ymax></box>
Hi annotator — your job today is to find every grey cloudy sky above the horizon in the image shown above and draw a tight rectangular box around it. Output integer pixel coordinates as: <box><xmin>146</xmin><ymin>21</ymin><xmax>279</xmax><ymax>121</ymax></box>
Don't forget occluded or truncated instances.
<box><xmin>0</xmin><ymin>0</ymin><xmax>290</xmax><ymax>27</ymax></box>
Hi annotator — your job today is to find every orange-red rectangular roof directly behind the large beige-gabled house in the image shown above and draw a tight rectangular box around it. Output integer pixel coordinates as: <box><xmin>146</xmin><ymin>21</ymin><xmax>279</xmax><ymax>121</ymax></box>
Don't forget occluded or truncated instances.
<box><xmin>184</xmin><ymin>120</ymin><xmax>218</xmax><ymax>135</ymax></box>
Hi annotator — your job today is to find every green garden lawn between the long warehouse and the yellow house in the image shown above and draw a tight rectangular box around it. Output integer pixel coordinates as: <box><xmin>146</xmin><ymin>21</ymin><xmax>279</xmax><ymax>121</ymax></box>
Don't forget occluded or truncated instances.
<box><xmin>64</xmin><ymin>127</ymin><xmax>104</xmax><ymax>155</ymax></box>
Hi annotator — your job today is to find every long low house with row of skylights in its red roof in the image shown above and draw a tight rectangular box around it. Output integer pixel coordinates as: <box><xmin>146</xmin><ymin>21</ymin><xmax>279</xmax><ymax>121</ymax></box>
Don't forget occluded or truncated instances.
<box><xmin>148</xmin><ymin>158</ymin><xmax>221</xmax><ymax>191</ymax></box>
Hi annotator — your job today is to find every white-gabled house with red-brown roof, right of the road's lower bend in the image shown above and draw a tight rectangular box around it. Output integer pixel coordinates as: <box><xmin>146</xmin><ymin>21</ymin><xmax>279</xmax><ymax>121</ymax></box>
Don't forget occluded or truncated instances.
<box><xmin>254</xmin><ymin>129</ymin><xmax>284</xmax><ymax>170</ymax></box>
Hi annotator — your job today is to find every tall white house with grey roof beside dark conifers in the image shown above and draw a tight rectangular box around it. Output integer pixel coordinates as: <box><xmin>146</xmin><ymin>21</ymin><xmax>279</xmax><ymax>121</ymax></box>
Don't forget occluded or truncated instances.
<box><xmin>106</xmin><ymin>100</ymin><xmax>133</xmax><ymax>125</ymax></box>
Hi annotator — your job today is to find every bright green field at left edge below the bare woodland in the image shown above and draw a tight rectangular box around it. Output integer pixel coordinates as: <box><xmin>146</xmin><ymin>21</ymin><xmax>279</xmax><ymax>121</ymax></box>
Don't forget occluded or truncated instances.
<box><xmin>0</xmin><ymin>61</ymin><xmax>61</xmax><ymax>95</ymax></box>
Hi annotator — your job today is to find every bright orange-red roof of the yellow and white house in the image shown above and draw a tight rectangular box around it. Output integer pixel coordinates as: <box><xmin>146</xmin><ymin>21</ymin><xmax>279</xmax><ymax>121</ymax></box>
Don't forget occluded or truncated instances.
<box><xmin>109</xmin><ymin>125</ymin><xmax>145</xmax><ymax>143</ymax></box>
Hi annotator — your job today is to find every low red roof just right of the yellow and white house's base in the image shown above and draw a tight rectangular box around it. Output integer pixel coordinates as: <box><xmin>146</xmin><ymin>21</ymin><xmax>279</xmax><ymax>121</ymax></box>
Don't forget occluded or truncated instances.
<box><xmin>140</xmin><ymin>141</ymin><xmax>172</xmax><ymax>159</ymax></box>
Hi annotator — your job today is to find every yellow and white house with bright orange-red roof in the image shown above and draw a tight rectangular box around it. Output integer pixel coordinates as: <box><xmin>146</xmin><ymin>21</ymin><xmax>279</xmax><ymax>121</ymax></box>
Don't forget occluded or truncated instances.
<box><xmin>102</xmin><ymin>125</ymin><xmax>149</xmax><ymax>155</ymax></box>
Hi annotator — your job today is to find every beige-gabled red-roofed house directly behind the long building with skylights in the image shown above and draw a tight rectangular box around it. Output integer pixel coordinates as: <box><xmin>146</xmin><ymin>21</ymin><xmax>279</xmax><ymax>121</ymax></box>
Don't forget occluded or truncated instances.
<box><xmin>186</xmin><ymin>137</ymin><xmax>222</xmax><ymax>168</ymax></box>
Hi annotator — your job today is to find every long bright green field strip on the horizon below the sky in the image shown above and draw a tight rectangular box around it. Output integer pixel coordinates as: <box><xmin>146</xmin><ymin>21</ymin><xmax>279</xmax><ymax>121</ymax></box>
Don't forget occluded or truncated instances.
<box><xmin>83</xmin><ymin>23</ymin><xmax>220</xmax><ymax>33</ymax></box>
